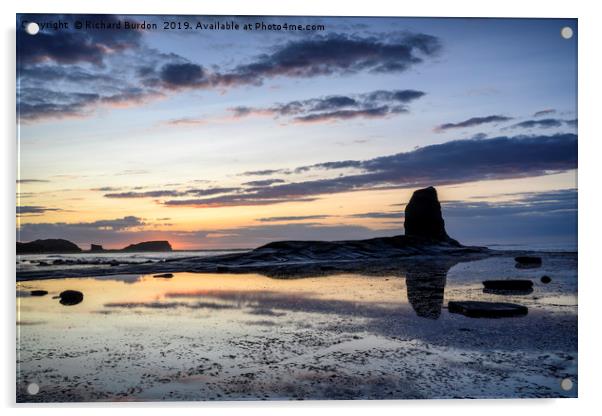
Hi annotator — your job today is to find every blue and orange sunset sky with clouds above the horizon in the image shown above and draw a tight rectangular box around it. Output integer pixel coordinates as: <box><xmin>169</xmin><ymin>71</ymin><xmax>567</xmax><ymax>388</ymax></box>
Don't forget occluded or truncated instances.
<box><xmin>17</xmin><ymin>15</ymin><xmax>578</xmax><ymax>250</ymax></box>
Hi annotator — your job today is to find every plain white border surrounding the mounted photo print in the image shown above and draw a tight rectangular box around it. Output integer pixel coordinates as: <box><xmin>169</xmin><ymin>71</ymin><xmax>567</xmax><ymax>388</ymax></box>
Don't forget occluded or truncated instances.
<box><xmin>0</xmin><ymin>0</ymin><xmax>602</xmax><ymax>416</ymax></box>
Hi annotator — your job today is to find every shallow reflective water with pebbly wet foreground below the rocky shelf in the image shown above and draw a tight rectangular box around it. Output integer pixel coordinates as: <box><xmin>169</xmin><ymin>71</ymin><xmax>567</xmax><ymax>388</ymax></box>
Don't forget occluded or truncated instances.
<box><xmin>17</xmin><ymin>253</ymin><xmax>577</xmax><ymax>401</ymax></box>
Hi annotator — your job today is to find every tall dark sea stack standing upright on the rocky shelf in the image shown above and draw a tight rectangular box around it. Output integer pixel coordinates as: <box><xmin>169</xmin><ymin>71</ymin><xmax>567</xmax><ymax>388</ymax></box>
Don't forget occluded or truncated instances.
<box><xmin>404</xmin><ymin>186</ymin><xmax>450</xmax><ymax>241</ymax></box>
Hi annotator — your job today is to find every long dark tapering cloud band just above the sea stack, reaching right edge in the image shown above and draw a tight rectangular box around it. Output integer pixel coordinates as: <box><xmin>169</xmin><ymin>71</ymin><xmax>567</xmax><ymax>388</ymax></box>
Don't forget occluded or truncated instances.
<box><xmin>165</xmin><ymin>134</ymin><xmax>577</xmax><ymax>207</ymax></box>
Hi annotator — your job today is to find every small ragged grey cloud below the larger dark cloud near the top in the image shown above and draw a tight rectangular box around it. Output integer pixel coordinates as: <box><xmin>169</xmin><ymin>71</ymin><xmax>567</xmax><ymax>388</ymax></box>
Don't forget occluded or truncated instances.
<box><xmin>230</xmin><ymin>90</ymin><xmax>425</xmax><ymax>123</ymax></box>
